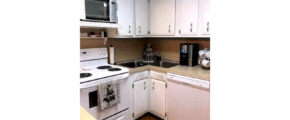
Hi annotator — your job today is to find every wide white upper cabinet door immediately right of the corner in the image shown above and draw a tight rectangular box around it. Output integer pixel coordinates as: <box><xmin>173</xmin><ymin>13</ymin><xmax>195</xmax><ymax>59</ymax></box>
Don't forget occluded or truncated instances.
<box><xmin>149</xmin><ymin>0</ymin><xmax>175</xmax><ymax>36</ymax></box>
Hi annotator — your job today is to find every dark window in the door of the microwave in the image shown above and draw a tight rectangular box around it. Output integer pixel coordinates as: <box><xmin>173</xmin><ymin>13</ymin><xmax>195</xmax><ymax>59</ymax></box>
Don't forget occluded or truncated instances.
<box><xmin>85</xmin><ymin>0</ymin><xmax>109</xmax><ymax>20</ymax></box>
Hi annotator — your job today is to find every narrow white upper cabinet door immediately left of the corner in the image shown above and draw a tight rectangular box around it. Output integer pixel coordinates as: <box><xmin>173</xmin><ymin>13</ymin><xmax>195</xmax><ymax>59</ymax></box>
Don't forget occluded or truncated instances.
<box><xmin>135</xmin><ymin>0</ymin><xmax>149</xmax><ymax>35</ymax></box>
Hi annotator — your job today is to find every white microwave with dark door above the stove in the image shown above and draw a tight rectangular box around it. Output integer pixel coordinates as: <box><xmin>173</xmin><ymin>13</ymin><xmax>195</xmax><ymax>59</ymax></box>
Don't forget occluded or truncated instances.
<box><xmin>79</xmin><ymin>0</ymin><xmax>117</xmax><ymax>23</ymax></box>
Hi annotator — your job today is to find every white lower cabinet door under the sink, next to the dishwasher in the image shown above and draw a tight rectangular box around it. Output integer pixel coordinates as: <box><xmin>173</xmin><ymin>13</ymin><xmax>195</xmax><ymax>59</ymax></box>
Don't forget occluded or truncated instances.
<box><xmin>150</xmin><ymin>79</ymin><xmax>166</xmax><ymax>117</ymax></box>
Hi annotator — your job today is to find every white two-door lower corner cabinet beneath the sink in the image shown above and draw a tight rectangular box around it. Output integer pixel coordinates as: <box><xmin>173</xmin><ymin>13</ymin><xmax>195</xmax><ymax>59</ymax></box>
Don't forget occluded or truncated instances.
<box><xmin>130</xmin><ymin>70</ymin><xmax>167</xmax><ymax>120</ymax></box>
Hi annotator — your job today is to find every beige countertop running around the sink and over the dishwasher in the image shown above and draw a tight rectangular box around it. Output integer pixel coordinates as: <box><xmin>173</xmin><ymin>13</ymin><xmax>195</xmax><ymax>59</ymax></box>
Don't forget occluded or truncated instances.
<box><xmin>119</xmin><ymin>62</ymin><xmax>211</xmax><ymax>81</ymax></box>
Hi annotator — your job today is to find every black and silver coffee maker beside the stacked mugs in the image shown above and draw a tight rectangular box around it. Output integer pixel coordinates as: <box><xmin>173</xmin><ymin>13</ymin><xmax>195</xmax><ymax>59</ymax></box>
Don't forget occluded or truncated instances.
<box><xmin>179</xmin><ymin>43</ymin><xmax>198</xmax><ymax>67</ymax></box>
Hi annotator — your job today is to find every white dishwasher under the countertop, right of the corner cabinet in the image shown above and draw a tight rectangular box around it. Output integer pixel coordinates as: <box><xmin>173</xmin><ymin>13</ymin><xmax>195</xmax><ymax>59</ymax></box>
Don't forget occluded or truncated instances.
<box><xmin>167</xmin><ymin>73</ymin><xmax>211</xmax><ymax>120</ymax></box>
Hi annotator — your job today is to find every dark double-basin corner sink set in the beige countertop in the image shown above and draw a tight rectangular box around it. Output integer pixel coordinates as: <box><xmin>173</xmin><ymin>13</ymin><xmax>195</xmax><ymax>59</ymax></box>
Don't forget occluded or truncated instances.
<box><xmin>119</xmin><ymin>61</ymin><xmax>178</xmax><ymax>68</ymax></box>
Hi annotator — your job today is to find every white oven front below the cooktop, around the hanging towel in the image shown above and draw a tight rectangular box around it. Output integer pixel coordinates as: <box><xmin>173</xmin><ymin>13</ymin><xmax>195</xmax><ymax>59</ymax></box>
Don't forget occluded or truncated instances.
<box><xmin>79</xmin><ymin>77</ymin><xmax>130</xmax><ymax>120</ymax></box>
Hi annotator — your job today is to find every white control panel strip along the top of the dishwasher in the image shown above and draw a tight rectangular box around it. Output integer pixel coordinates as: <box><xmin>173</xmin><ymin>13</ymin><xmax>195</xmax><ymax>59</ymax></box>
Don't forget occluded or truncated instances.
<box><xmin>167</xmin><ymin>73</ymin><xmax>210</xmax><ymax>88</ymax></box>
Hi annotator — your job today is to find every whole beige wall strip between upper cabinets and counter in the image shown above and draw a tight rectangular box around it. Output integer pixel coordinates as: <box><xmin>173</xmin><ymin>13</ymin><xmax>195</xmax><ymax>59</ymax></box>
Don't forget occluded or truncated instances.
<box><xmin>79</xmin><ymin>38</ymin><xmax>211</xmax><ymax>62</ymax></box>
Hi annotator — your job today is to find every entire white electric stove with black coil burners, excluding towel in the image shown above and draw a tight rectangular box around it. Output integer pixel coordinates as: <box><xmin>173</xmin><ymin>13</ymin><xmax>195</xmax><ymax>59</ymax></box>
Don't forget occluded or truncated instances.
<box><xmin>79</xmin><ymin>48</ymin><xmax>130</xmax><ymax>120</ymax></box>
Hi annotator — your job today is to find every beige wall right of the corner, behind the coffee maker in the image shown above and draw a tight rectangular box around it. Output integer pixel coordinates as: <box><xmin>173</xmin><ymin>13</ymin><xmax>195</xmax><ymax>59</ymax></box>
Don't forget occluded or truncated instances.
<box><xmin>146</xmin><ymin>38</ymin><xmax>211</xmax><ymax>61</ymax></box>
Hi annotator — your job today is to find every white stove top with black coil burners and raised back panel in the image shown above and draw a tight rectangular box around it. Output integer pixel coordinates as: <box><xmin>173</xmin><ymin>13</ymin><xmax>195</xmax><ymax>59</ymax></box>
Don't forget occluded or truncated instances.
<box><xmin>79</xmin><ymin>47</ymin><xmax>129</xmax><ymax>84</ymax></box>
